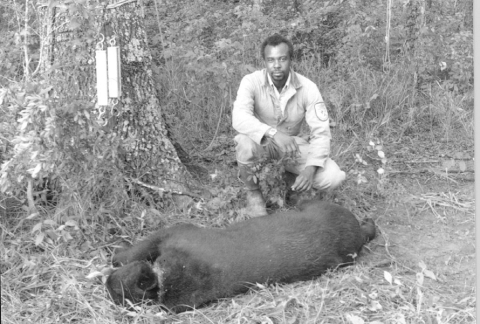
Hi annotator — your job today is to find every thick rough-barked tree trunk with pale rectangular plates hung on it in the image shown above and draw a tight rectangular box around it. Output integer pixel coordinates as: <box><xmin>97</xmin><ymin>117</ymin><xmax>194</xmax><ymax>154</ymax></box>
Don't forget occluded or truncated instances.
<box><xmin>41</xmin><ymin>0</ymin><xmax>195</xmax><ymax>205</ymax></box>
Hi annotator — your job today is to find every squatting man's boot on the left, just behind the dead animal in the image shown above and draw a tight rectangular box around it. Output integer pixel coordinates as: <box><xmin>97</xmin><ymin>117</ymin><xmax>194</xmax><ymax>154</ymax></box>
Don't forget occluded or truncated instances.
<box><xmin>238</xmin><ymin>165</ymin><xmax>267</xmax><ymax>217</ymax></box>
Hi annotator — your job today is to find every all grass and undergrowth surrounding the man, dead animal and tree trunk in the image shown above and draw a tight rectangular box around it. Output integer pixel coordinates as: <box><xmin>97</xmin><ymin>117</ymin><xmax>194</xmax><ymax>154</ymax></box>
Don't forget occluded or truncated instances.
<box><xmin>0</xmin><ymin>0</ymin><xmax>476</xmax><ymax>324</ymax></box>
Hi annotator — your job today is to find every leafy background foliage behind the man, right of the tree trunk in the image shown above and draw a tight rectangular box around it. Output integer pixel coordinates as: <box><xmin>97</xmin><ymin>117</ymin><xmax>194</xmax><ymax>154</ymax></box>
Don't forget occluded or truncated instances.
<box><xmin>149</xmin><ymin>1</ymin><xmax>473</xmax><ymax>157</ymax></box>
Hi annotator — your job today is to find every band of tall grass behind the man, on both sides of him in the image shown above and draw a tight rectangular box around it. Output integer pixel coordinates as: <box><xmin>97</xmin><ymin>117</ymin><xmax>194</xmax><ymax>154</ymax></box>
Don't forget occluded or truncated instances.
<box><xmin>156</xmin><ymin>49</ymin><xmax>473</xmax><ymax>157</ymax></box>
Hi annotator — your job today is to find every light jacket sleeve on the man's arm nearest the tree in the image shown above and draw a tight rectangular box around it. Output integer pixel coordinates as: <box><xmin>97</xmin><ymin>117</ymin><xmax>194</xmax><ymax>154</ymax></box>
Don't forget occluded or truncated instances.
<box><xmin>232</xmin><ymin>74</ymin><xmax>270</xmax><ymax>144</ymax></box>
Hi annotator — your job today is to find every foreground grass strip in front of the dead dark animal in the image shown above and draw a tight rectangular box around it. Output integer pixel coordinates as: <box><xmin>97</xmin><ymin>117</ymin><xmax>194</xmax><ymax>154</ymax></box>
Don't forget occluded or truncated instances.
<box><xmin>1</xmin><ymin>205</ymin><xmax>475</xmax><ymax>323</ymax></box>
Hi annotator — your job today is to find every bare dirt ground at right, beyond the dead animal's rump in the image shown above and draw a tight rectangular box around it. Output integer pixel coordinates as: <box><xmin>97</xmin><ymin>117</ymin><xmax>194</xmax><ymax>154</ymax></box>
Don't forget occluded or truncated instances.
<box><xmin>338</xmin><ymin>136</ymin><xmax>476</xmax><ymax>312</ymax></box>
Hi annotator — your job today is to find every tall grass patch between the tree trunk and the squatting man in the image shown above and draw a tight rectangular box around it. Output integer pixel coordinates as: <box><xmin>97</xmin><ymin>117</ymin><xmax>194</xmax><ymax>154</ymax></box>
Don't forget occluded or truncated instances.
<box><xmin>155</xmin><ymin>60</ymin><xmax>240</xmax><ymax>152</ymax></box>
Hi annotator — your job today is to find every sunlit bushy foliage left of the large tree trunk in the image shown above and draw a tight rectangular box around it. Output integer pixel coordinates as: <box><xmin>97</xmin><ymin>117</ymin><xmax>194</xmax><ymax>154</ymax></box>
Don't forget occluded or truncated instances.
<box><xmin>0</xmin><ymin>1</ymin><xmax>129</xmax><ymax>215</ymax></box>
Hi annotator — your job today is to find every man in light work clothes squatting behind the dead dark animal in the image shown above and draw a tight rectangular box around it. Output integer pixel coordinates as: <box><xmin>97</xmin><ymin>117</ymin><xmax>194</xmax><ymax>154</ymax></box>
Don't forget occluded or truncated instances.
<box><xmin>232</xmin><ymin>34</ymin><xmax>345</xmax><ymax>217</ymax></box>
